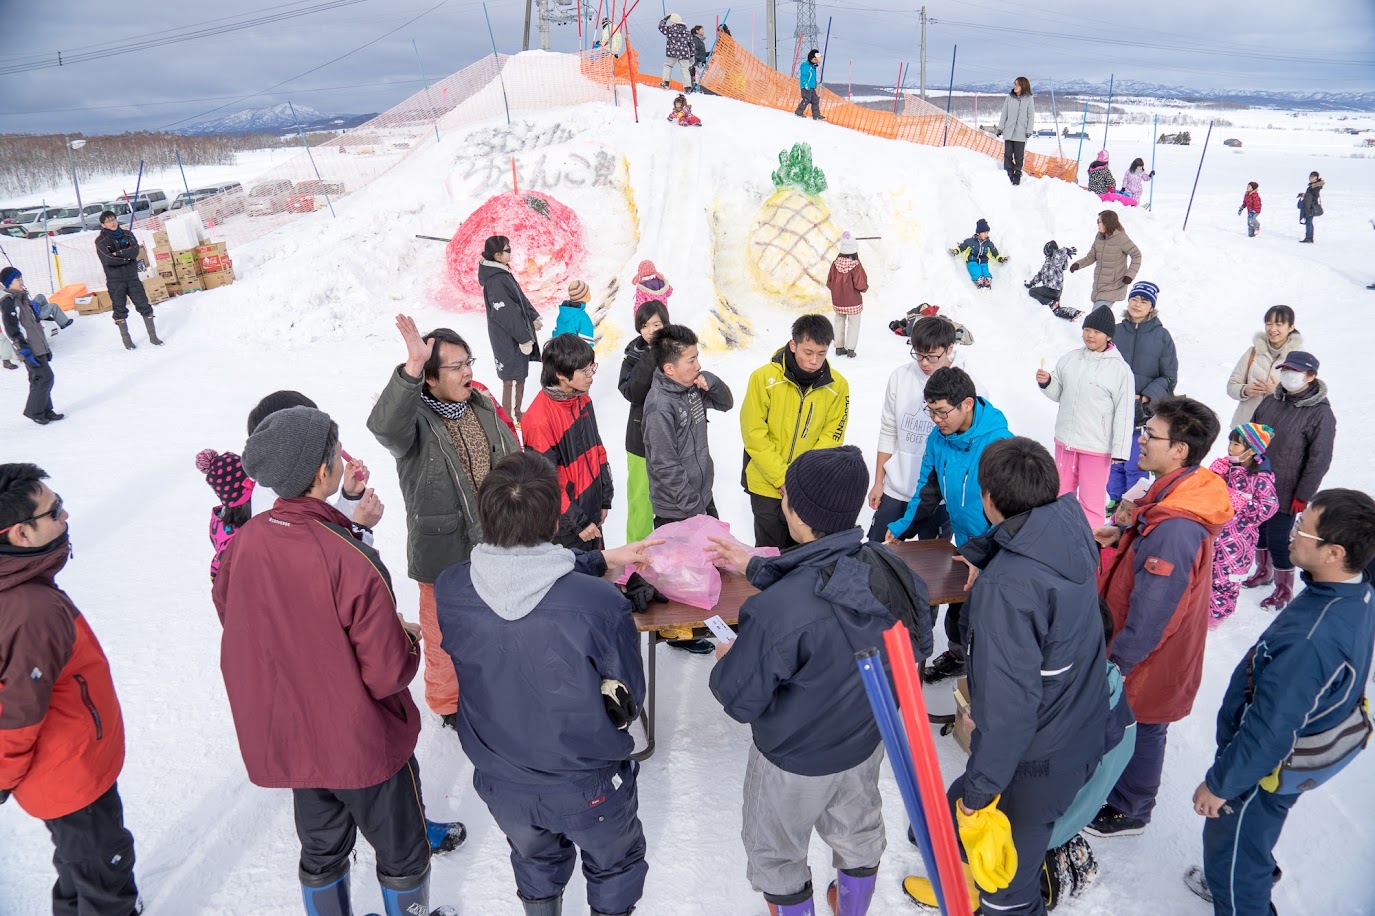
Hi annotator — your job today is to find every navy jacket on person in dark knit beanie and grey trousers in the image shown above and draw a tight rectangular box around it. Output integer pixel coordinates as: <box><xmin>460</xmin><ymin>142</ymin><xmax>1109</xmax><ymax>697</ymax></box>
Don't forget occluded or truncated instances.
<box><xmin>711</xmin><ymin>525</ymin><xmax>929</xmax><ymax>776</ymax></box>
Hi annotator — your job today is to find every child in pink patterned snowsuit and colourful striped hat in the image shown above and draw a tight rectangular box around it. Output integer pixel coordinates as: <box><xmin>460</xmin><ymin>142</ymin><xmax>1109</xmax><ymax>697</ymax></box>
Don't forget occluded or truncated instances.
<box><xmin>1207</xmin><ymin>424</ymin><xmax>1279</xmax><ymax>630</ymax></box>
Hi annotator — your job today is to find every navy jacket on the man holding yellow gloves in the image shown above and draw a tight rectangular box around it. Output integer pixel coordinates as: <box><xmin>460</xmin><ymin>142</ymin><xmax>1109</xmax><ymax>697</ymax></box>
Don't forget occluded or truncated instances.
<box><xmin>960</xmin><ymin>494</ymin><xmax>1108</xmax><ymax>810</ymax></box>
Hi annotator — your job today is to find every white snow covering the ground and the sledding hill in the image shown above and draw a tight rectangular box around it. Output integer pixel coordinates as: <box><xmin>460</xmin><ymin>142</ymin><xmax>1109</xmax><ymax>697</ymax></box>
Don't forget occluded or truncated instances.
<box><xmin>8</xmin><ymin>57</ymin><xmax>1375</xmax><ymax>916</ymax></box>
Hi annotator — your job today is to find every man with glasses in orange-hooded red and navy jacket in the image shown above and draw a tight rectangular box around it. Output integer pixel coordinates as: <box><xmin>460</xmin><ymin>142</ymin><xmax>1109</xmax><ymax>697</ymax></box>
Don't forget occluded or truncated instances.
<box><xmin>1085</xmin><ymin>397</ymin><xmax>1233</xmax><ymax>836</ymax></box>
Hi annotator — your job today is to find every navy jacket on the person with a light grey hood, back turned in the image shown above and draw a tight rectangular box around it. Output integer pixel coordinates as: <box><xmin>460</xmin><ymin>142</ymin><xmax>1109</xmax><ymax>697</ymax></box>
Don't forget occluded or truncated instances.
<box><xmin>435</xmin><ymin>553</ymin><xmax>645</xmax><ymax>787</ymax></box>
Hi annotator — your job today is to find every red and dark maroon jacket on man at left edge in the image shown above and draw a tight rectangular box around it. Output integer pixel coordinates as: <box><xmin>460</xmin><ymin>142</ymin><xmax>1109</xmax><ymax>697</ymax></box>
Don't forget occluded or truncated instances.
<box><xmin>0</xmin><ymin>538</ymin><xmax>124</xmax><ymax>820</ymax></box>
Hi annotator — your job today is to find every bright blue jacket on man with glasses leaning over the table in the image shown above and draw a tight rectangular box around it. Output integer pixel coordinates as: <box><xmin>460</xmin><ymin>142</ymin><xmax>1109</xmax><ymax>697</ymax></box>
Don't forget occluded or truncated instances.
<box><xmin>888</xmin><ymin>397</ymin><xmax>1012</xmax><ymax>546</ymax></box>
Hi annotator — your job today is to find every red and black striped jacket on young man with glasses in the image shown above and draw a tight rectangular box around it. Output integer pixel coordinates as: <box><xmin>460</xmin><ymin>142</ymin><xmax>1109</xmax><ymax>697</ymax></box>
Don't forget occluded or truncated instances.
<box><xmin>520</xmin><ymin>391</ymin><xmax>613</xmax><ymax>546</ymax></box>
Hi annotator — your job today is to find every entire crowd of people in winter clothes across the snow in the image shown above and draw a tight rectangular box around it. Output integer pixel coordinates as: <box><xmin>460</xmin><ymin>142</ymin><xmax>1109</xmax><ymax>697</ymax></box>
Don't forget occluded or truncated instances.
<box><xmin>0</xmin><ymin>107</ymin><xmax>1375</xmax><ymax>916</ymax></box>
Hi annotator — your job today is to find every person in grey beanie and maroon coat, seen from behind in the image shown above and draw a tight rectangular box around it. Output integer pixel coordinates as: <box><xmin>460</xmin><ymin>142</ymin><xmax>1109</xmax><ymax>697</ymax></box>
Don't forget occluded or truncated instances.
<box><xmin>212</xmin><ymin>407</ymin><xmax>451</xmax><ymax>915</ymax></box>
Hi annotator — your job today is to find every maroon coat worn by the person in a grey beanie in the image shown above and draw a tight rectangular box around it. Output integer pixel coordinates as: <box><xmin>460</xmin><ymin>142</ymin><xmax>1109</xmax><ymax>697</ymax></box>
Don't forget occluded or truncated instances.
<box><xmin>213</xmin><ymin>497</ymin><xmax>421</xmax><ymax>789</ymax></box>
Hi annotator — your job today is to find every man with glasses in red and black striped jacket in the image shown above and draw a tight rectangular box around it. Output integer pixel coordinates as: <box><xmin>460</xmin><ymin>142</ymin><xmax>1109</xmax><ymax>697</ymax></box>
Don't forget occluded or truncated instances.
<box><xmin>520</xmin><ymin>334</ymin><xmax>615</xmax><ymax>550</ymax></box>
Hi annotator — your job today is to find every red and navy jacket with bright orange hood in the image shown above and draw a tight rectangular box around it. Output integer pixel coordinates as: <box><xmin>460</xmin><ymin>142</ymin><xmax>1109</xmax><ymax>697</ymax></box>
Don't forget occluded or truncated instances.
<box><xmin>1099</xmin><ymin>468</ymin><xmax>1235</xmax><ymax>723</ymax></box>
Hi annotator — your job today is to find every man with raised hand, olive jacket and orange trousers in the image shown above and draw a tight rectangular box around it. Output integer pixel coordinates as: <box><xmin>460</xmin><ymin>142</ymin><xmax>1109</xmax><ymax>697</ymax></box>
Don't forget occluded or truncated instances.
<box><xmin>367</xmin><ymin>315</ymin><xmax>520</xmax><ymax>728</ymax></box>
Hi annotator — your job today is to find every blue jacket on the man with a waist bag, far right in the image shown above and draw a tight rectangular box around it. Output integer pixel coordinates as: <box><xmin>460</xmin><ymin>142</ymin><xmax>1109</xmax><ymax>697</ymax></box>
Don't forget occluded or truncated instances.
<box><xmin>1205</xmin><ymin>572</ymin><xmax>1375</xmax><ymax>799</ymax></box>
